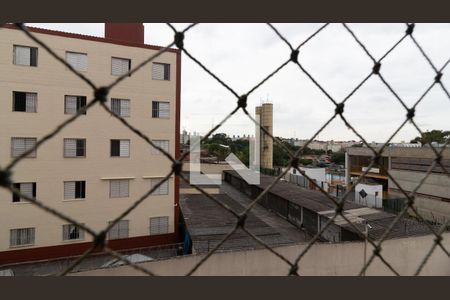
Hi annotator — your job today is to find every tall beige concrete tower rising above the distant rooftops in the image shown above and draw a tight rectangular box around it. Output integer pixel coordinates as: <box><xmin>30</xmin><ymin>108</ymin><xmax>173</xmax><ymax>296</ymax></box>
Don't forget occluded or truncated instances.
<box><xmin>255</xmin><ymin>103</ymin><xmax>273</xmax><ymax>169</ymax></box>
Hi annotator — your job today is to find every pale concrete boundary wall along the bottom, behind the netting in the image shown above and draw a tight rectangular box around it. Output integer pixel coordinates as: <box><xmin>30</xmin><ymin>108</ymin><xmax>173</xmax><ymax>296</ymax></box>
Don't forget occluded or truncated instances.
<box><xmin>71</xmin><ymin>233</ymin><xmax>450</xmax><ymax>276</ymax></box>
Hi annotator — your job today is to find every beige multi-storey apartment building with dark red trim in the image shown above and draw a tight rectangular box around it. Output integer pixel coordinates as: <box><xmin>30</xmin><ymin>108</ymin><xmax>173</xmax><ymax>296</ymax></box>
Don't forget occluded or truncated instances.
<box><xmin>0</xmin><ymin>23</ymin><xmax>181</xmax><ymax>265</ymax></box>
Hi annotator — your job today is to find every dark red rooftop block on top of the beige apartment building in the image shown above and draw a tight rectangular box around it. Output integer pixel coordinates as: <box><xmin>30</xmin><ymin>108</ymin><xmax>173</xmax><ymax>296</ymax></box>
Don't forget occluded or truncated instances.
<box><xmin>105</xmin><ymin>23</ymin><xmax>144</xmax><ymax>44</ymax></box>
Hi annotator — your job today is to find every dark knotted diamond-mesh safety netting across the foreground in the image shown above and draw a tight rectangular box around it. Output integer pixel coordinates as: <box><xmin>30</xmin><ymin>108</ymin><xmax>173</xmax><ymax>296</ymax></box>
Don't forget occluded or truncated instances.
<box><xmin>0</xmin><ymin>23</ymin><xmax>450</xmax><ymax>275</ymax></box>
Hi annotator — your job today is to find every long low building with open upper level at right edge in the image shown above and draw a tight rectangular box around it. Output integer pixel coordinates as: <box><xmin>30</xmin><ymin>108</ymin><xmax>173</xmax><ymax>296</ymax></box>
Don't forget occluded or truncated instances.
<box><xmin>345</xmin><ymin>147</ymin><xmax>450</xmax><ymax>223</ymax></box>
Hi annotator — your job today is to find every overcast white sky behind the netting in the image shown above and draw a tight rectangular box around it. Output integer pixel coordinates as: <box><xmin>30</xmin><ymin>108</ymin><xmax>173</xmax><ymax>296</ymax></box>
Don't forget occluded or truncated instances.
<box><xmin>28</xmin><ymin>23</ymin><xmax>450</xmax><ymax>142</ymax></box>
